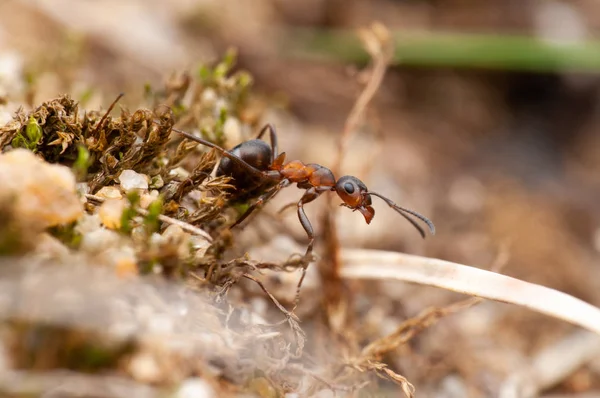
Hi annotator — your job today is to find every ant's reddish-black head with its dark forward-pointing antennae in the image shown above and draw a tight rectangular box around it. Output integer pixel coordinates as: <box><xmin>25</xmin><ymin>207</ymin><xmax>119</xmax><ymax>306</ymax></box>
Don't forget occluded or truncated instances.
<box><xmin>335</xmin><ymin>176</ymin><xmax>435</xmax><ymax>238</ymax></box>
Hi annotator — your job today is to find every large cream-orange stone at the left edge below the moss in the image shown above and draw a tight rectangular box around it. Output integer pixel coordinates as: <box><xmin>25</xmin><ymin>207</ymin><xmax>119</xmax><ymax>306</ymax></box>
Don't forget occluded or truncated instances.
<box><xmin>0</xmin><ymin>149</ymin><xmax>83</xmax><ymax>230</ymax></box>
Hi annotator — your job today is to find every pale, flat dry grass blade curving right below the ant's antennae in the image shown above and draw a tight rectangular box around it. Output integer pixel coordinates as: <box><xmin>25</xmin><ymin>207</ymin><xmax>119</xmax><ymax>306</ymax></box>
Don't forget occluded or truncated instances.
<box><xmin>341</xmin><ymin>249</ymin><xmax>600</xmax><ymax>334</ymax></box>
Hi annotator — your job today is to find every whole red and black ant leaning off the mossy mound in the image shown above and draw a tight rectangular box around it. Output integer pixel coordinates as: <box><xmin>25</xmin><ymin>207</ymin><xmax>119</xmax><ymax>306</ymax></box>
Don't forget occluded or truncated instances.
<box><xmin>172</xmin><ymin>124</ymin><xmax>435</xmax><ymax>261</ymax></box>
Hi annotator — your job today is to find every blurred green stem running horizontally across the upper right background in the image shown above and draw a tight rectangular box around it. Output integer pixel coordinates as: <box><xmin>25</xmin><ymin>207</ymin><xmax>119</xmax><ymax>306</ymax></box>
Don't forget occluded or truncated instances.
<box><xmin>282</xmin><ymin>30</ymin><xmax>600</xmax><ymax>72</ymax></box>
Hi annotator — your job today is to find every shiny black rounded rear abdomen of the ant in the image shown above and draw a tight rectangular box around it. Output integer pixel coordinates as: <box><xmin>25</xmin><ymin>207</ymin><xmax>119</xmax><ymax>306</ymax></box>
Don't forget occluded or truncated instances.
<box><xmin>217</xmin><ymin>140</ymin><xmax>277</xmax><ymax>202</ymax></box>
